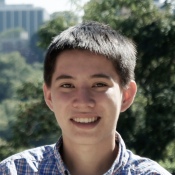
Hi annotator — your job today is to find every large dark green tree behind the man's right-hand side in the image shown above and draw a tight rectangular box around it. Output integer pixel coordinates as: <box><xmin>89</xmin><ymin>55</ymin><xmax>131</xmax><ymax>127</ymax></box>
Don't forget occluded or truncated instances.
<box><xmin>83</xmin><ymin>0</ymin><xmax>175</xmax><ymax>164</ymax></box>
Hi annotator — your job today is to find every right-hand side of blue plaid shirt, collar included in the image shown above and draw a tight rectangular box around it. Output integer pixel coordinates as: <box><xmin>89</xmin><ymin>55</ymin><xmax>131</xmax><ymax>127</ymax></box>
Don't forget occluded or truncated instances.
<box><xmin>114</xmin><ymin>133</ymin><xmax>171</xmax><ymax>175</ymax></box>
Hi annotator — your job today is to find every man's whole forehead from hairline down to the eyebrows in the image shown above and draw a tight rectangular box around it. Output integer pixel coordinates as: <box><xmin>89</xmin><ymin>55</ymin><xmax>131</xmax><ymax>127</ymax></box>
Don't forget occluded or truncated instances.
<box><xmin>53</xmin><ymin>50</ymin><xmax>119</xmax><ymax>83</ymax></box>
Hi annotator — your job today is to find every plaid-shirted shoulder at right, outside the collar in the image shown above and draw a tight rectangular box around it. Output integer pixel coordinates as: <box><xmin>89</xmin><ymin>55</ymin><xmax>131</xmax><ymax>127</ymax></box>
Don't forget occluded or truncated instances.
<box><xmin>126</xmin><ymin>150</ymin><xmax>171</xmax><ymax>175</ymax></box>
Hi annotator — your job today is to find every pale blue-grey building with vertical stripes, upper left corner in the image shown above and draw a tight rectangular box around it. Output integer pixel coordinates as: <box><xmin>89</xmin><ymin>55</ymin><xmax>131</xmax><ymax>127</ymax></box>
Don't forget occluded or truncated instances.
<box><xmin>0</xmin><ymin>0</ymin><xmax>49</xmax><ymax>36</ymax></box>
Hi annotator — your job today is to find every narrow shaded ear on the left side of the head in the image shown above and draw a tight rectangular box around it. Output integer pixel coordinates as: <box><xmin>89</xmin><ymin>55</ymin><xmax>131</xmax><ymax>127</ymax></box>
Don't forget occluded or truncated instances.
<box><xmin>43</xmin><ymin>83</ymin><xmax>53</xmax><ymax>111</ymax></box>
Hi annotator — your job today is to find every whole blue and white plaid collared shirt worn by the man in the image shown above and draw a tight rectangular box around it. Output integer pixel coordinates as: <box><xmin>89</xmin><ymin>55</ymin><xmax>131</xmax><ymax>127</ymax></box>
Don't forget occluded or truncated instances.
<box><xmin>0</xmin><ymin>133</ymin><xmax>170</xmax><ymax>175</ymax></box>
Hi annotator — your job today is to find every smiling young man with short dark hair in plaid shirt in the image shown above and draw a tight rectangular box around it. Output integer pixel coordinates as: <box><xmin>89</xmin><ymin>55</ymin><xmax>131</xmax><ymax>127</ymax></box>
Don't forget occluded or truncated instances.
<box><xmin>0</xmin><ymin>22</ymin><xmax>170</xmax><ymax>175</ymax></box>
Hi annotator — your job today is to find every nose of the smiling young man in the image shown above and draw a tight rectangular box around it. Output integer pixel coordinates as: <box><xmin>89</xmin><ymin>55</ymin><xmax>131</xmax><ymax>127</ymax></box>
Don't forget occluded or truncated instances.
<box><xmin>73</xmin><ymin>88</ymin><xmax>95</xmax><ymax>108</ymax></box>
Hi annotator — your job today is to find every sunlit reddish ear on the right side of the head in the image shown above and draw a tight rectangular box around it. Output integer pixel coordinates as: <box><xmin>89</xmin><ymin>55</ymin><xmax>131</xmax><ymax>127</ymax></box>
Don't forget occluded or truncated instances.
<box><xmin>121</xmin><ymin>80</ymin><xmax>137</xmax><ymax>112</ymax></box>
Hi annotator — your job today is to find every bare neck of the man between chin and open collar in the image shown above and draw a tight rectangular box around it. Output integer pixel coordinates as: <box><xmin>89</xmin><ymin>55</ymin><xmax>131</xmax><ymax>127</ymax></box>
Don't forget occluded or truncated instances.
<box><xmin>62</xmin><ymin>137</ymin><xmax>118</xmax><ymax>175</ymax></box>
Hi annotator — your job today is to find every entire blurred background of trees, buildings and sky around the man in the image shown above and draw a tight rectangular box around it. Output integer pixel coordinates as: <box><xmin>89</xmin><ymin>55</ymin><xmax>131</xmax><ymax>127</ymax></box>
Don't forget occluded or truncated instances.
<box><xmin>0</xmin><ymin>0</ymin><xmax>175</xmax><ymax>173</ymax></box>
